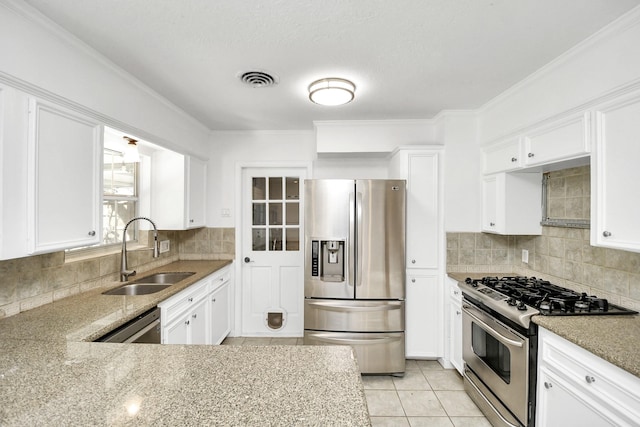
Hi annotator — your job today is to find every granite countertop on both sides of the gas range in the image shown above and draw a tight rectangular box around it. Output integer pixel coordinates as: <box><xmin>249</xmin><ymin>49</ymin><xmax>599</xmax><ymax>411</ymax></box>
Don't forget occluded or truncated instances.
<box><xmin>448</xmin><ymin>273</ymin><xmax>640</xmax><ymax>377</ymax></box>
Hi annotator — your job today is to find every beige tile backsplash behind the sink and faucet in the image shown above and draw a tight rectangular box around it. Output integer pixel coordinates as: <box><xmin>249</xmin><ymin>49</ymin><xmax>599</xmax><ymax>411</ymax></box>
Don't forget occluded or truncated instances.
<box><xmin>0</xmin><ymin>228</ymin><xmax>235</xmax><ymax>318</ymax></box>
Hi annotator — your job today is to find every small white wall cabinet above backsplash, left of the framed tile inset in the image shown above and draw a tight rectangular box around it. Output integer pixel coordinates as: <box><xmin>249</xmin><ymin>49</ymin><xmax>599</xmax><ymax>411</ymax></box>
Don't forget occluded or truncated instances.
<box><xmin>482</xmin><ymin>172</ymin><xmax>542</xmax><ymax>235</ymax></box>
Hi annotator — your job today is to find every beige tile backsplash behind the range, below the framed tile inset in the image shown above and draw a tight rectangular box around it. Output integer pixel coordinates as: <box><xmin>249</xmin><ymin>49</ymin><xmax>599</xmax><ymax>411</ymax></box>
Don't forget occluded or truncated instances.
<box><xmin>447</xmin><ymin>227</ymin><xmax>640</xmax><ymax>311</ymax></box>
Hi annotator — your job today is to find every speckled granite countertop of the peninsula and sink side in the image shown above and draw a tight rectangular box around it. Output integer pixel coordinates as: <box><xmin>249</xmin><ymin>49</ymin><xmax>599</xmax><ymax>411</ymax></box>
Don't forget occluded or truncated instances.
<box><xmin>0</xmin><ymin>261</ymin><xmax>370</xmax><ymax>426</ymax></box>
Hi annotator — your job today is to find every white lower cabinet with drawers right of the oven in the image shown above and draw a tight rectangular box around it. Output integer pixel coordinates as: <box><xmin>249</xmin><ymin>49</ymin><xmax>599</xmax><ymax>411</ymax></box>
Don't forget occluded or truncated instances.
<box><xmin>536</xmin><ymin>328</ymin><xmax>640</xmax><ymax>427</ymax></box>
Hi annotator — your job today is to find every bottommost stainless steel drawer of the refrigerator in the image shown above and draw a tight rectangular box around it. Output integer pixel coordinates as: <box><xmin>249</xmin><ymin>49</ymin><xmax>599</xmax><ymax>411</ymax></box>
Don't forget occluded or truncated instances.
<box><xmin>304</xmin><ymin>331</ymin><xmax>405</xmax><ymax>374</ymax></box>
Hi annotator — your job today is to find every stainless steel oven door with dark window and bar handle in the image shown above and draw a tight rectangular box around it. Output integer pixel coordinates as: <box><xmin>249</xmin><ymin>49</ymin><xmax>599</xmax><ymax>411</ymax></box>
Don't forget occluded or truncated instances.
<box><xmin>462</xmin><ymin>301</ymin><xmax>529</xmax><ymax>425</ymax></box>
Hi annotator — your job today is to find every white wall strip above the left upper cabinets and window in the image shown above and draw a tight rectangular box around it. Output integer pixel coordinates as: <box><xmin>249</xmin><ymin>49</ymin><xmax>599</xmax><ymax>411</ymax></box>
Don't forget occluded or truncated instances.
<box><xmin>0</xmin><ymin>0</ymin><xmax>209</xmax><ymax>157</ymax></box>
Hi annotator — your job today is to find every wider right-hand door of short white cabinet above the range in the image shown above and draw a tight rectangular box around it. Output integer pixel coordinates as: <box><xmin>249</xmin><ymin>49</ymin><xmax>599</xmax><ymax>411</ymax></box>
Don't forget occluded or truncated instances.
<box><xmin>523</xmin><ymin>112</ymin><xmax>591</xmax><ymax>166</ymax></box>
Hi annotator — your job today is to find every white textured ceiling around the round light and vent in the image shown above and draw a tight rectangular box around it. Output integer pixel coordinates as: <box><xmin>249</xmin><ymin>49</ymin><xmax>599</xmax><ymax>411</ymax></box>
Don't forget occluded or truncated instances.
<box><xmin>17</xmin><ymin>0</ymin><xmax>640</xmax><ymax>130</ymax></box>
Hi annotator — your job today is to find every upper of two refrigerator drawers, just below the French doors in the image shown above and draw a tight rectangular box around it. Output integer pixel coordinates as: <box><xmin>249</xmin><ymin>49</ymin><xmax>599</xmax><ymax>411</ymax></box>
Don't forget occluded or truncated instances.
<box><xmin>304</xmin><ymin>299</ymin><xmax>404</xmax><ymax>332</ymax></box>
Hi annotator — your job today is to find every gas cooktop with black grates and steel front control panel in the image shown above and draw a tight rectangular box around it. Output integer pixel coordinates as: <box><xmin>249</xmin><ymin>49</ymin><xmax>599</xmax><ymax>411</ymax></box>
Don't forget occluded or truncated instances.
<box><xmin>461</xmin><ymin>276</ymin><xmax>637</xmax><ymax>332</ymax></box>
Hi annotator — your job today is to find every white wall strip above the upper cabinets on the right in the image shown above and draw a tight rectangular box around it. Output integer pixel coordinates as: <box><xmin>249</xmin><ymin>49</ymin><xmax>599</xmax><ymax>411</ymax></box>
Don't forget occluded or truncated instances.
<box><xmin>479</xmin><ymin>7</ymin><xmax>640</xmax><ymax>144</ymax></box>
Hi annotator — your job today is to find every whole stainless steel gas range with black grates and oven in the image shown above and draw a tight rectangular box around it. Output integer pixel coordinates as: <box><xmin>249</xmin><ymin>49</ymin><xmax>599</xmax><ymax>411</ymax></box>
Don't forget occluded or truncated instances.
<box><xmin>460</xmin><ymin>276</ymin><xmax>636</xmax><ymax>427</ymax></box>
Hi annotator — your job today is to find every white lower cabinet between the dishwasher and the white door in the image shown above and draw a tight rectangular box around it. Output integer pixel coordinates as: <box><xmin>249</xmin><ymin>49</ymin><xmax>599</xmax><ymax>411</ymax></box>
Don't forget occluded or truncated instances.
<box><xmin>158</xmin><ymin>267</ymin><xmax>231</xmax><ymax>344</ymax></box>
